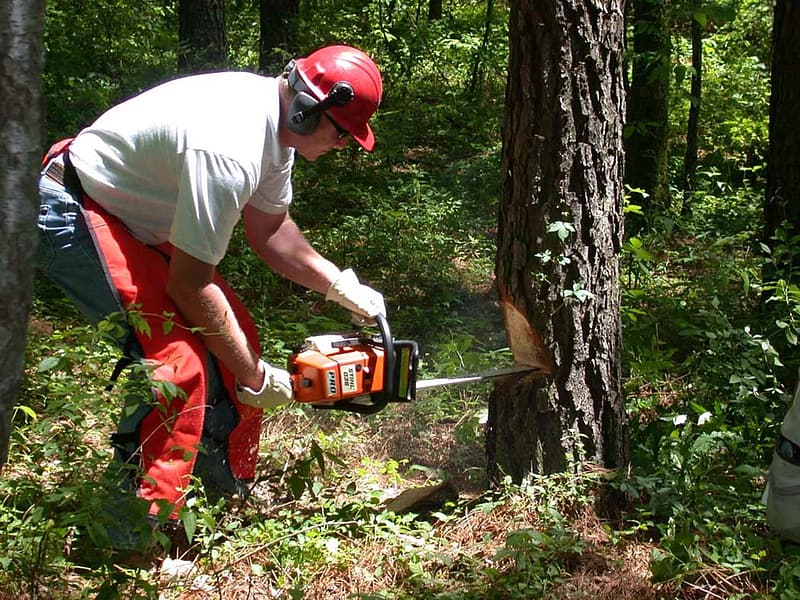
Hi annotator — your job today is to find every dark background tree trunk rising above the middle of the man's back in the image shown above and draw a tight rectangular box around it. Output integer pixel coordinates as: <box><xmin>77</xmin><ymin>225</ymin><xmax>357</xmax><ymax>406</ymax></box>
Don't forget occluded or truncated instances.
<box><xmin>178</xmin><ymin>0</ymin><xmax>228</xmax><ymax>73</ymax></box>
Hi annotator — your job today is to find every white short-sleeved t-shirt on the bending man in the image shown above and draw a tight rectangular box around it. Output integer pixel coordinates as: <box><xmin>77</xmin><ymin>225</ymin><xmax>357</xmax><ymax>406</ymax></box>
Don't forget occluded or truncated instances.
<box><xmin>69</xmin><ymin>72</ymin><xmax>294</xmax><ymax>265</ymax></box>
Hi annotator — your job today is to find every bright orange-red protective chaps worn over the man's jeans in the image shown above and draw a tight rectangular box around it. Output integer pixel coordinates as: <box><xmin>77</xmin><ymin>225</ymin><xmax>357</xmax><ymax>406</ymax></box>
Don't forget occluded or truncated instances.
<box><xmin>45</xmin><ymin>140</ymin><xmax>262</xmax><ymax>518</ymax></box>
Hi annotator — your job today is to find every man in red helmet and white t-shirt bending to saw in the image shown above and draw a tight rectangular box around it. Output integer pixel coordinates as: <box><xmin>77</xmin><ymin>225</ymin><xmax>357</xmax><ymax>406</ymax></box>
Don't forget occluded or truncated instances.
<box><xmin>39</xmin><ymin>46</ymin><xmax>386</xmax><ymax>552</ymax></box>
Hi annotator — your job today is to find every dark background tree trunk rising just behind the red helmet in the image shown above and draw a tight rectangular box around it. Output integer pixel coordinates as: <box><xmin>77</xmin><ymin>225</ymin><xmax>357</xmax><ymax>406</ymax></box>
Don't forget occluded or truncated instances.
<box><xmin>258</xmin><ymin>0</ymin><xmax>300</xmax><ymax>74</ymax></box>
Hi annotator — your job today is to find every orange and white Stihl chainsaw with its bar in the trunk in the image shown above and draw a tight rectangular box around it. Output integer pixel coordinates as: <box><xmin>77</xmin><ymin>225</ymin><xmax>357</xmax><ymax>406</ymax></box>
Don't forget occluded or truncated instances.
<box><xmin>288</xmin><ymin>315</ymin><xmax>537</xmax><ymax>414</ymax></box>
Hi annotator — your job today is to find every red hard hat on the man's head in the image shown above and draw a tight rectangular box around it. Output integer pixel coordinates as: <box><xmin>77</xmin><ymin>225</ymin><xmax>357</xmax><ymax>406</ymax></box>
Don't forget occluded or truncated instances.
<box><xmin>294</xmin><ymin>46</ymin><xmax>383</xmax><ymax>152</ymax></box>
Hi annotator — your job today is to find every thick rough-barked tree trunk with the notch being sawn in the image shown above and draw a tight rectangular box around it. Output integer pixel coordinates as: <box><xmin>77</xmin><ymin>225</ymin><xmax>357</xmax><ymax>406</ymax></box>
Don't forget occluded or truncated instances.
<box><xmin>487</xmin><ymin>0</ymin><xmax>628</xmax><ymax>482</ymax></box>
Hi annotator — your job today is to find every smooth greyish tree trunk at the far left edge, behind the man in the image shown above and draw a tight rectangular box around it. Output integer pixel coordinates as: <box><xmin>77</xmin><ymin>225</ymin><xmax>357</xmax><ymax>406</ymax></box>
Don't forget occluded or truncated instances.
<box><xmin>0</xmin><ymin>0</ymin><xmax>44</xmax><ymax>471</ymax></box>
